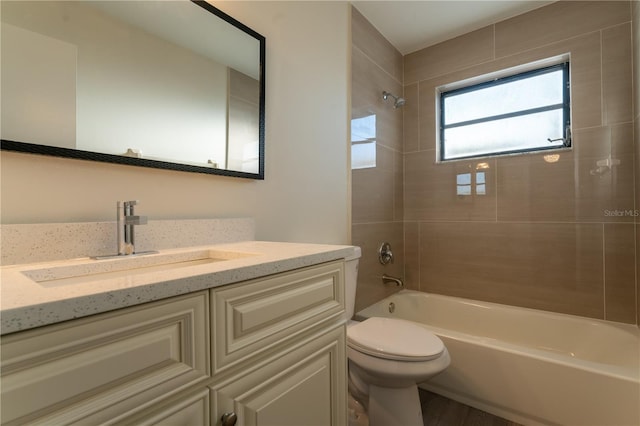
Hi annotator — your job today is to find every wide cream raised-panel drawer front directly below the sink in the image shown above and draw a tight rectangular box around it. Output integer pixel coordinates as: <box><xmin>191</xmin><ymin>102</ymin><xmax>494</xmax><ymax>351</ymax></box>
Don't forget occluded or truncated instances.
<box><xmin>0</xmin><ymin>291</ymin><xmax>209</xmax><ymax>424</ymax></box>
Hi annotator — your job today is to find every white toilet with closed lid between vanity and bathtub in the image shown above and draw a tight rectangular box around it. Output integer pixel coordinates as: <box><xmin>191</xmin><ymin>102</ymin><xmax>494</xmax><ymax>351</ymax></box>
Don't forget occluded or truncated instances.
<box><xmin>345</xmin><ymin>247</ymin><xmax>450</xmax><ymax>426</ymax></box>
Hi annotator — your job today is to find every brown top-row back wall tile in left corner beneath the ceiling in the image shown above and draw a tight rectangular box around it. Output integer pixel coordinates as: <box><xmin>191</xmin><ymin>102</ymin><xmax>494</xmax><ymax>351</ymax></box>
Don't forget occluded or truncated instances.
<box><xmin>404</xmin><ymin>26</ymin><xmax>493</xmax><ymax>84</ymax></box>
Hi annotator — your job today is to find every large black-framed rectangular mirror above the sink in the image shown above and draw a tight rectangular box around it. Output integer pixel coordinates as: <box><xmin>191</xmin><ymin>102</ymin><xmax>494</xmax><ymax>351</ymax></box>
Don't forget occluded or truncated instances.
<box><xmin>0</xmin><ymin>0</ymin><xmax>265</xmax><ymax>179</ymax></box>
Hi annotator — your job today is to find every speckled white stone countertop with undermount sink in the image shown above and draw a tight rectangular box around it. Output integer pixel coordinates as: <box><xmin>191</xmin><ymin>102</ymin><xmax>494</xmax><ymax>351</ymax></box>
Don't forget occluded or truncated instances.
<box><xmin>0</xmin><ymin>241</ymin><xmax>355</xmax><ymax>334</ymax></box>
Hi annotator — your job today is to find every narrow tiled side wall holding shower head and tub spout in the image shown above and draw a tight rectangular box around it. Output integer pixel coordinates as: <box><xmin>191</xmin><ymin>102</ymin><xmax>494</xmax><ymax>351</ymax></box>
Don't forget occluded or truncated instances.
<box><xmin>351</xmin><ymin>8</ymin><xmax>404</xmax><ymax>311</ymax></box>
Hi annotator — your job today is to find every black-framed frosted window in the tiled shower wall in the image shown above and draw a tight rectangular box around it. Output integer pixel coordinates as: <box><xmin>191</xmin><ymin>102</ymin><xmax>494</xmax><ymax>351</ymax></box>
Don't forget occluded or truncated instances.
<box><xmin>439</xmin><ymin>62</ymin><xmax>571</xmax><ymax>161</ymax></box>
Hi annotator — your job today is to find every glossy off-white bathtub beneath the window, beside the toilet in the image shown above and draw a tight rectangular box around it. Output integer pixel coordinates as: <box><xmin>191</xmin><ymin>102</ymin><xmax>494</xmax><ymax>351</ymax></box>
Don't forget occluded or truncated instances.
<box><xmin>357</xmin><ymin>290</ymin><xmax>640</xmax><ymax>426</ymax></box>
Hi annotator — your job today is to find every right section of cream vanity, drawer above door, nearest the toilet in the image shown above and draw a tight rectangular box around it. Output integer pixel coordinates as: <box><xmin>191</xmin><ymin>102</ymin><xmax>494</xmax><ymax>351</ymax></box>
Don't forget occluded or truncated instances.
<box><xmin>211</xmin><ymin>262</ymin><xmax>347</xmax><ymax>426</ymax></box>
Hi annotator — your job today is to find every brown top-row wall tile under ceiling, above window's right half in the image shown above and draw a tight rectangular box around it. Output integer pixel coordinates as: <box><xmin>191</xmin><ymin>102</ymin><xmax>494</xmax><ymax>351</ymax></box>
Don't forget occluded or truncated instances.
<box><xmin>495</xmin><ymin>1</ymin><xmax>631</xmax><ymax>58</ymax></box>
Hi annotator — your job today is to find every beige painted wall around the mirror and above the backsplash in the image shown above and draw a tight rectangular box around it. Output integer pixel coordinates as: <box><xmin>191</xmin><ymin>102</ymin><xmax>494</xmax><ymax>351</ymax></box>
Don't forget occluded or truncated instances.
<box><xmin>0</xmin><ymin>1</ymin><xmax>350</xmax><ymax>243</ymax></box>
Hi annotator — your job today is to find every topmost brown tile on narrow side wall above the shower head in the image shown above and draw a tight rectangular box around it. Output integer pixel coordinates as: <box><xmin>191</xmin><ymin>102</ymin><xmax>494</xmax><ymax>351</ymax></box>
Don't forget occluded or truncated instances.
<box><xmin>351</xmin><ymin>7</ymin><xmax>402</xmax><ymax>83</ymax></box>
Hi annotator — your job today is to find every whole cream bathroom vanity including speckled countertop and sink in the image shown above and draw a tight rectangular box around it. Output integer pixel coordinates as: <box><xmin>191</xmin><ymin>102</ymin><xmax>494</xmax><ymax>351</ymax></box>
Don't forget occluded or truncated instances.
<box><xmin>1</xmin><ymin>242</ymin><xmax>353</xmax><ymax>426</ymax></box>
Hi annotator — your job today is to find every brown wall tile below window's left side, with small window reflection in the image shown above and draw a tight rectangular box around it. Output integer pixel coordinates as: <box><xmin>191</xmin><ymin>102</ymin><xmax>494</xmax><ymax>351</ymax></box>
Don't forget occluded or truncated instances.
<box><xmin>404</xmin><ymin>150</ymin><xmax>496</xmax><ymax>221</ymax></box>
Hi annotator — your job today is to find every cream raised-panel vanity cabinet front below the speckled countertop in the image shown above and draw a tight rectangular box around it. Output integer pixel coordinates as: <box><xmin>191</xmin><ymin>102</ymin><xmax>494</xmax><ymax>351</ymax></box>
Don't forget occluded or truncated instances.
<box><xmin>0</xmin><ymin>260</ymin><xmax>347</xmax><ymax>426</ymax></box>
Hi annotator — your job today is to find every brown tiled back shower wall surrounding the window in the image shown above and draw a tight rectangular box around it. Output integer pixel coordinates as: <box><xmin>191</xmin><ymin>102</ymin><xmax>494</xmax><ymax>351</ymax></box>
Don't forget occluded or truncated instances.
<box><xmin>404</xmin><ymin>1</ymin><xmax>640</xmax><ymax>323</ymax></box>
